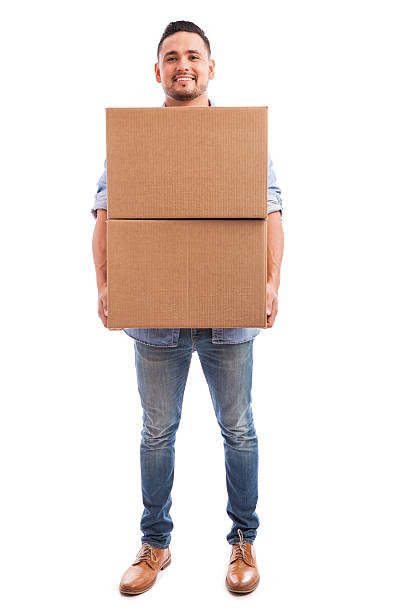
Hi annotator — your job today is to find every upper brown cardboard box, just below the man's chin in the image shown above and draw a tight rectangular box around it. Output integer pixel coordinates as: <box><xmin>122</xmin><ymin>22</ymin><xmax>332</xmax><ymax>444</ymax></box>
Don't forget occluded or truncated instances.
<box><xmin>106</xmin><ymin>106</ymin><xmax>268</xmax><ymax>219</ymax></box>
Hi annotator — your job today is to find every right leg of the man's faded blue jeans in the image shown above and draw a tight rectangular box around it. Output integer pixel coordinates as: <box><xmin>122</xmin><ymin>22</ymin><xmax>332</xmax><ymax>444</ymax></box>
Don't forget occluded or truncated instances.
<box><xmin>196</xmin><ymin>334</ymin><xmax>259</xmax><ymax>544</ymax></box>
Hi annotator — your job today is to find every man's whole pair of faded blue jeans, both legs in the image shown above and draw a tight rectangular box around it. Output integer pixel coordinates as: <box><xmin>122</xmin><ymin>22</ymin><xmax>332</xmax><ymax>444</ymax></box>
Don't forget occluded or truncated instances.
<box><xmin>134</xmin><ymin>328</ymin><xmax>259</xmax><ymax>548</ymax></box>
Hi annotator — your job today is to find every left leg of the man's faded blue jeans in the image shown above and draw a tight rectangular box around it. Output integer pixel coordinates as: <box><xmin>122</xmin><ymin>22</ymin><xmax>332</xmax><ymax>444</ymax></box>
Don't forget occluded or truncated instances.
<box><xmin>135</xmin><ymin>339</ymin><xmax>192</xmax><ymax>548</ymax></box>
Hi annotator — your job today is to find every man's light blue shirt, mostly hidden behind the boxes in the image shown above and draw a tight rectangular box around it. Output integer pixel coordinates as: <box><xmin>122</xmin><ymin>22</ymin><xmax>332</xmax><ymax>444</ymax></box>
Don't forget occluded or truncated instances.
<box><xmin>91</xmin><ymin>100</ymin><xmax>282</xmax><ymax>346</ymax></box>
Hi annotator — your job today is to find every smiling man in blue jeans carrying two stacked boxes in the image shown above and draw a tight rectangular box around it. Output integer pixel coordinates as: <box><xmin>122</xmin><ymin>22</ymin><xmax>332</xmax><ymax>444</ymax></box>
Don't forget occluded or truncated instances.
<box><xmin>92</xmin><ymin>21</ymin><xmax>283</xmax><ymax>594</ymax></box>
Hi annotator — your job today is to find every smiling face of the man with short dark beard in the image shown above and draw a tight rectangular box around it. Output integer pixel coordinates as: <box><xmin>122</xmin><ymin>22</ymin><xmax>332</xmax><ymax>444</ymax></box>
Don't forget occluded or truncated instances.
<box><xmin>154</xmin><ymin>32</ymin><xmax>215</xmax><ymax>101</ymax></box>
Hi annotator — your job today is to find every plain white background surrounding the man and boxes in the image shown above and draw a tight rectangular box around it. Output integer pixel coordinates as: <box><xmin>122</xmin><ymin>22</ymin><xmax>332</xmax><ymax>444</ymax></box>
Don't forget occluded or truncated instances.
<box><xmin>0</xmin><ymin>0</ymin><xmax>408</xmax><ymax>612</ymax></box>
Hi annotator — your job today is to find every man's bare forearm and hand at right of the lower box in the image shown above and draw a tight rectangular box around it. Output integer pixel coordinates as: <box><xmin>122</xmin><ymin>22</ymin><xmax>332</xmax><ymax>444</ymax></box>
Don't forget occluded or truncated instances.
<box><xmin>266</xmin><ymin>211</ymin><xmax>284</xmax><ymax>327</ymax></box>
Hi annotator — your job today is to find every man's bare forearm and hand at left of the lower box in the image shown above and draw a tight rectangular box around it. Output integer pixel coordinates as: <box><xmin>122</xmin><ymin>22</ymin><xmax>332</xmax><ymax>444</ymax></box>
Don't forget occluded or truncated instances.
<box><xmin>92</xmin><ymin>208</ymin><xmax>108</xmax><ymax>327</ymax></box>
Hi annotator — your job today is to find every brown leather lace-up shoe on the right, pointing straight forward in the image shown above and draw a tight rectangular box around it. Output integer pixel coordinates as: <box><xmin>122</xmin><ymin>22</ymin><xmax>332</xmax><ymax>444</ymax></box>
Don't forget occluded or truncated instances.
<box><xmin>225</xmin><ymin>529</ymin><xmax>259</xmax><ymax>593</ymax></box>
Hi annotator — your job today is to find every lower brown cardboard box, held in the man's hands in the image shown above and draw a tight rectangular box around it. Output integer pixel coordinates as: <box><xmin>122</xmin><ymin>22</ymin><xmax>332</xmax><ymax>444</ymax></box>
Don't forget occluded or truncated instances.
<box><xmin>108</xmin><ymin>219</ymin><xmax>267</xmax><ymax>328</ymax></box>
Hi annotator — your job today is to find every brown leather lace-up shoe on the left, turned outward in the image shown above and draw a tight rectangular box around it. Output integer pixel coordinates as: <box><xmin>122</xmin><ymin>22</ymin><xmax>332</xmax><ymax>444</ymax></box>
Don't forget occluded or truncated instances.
<box><xmin>119</xmin><ymin>542</ymin><xmax>171</xmax><ymax>595</ymax></box>
